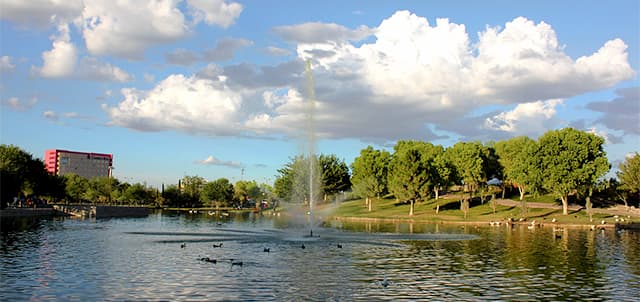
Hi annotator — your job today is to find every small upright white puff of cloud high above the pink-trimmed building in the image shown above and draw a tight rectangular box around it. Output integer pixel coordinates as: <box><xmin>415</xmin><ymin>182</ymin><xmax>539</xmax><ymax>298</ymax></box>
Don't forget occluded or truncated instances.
<box><xmin>35</xmin><ymin>24</ymin><xmax>78</xmax><ymax>78</ymax></box>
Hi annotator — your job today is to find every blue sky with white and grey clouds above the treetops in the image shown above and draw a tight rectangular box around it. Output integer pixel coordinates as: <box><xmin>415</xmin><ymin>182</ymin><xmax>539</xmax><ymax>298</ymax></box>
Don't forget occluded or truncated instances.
<box><xmin>0</xmin><ymin>0</ymin><xmax>640</xmax><ymax>187</ymax></box>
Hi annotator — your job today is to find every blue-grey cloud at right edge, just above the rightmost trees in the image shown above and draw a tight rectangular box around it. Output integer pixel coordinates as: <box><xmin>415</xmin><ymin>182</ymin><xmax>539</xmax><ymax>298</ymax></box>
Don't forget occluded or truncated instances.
<box><xmin>587</xmin><ymin>87</ymin><xmax>640</xmax><ymax>135</ymax></box>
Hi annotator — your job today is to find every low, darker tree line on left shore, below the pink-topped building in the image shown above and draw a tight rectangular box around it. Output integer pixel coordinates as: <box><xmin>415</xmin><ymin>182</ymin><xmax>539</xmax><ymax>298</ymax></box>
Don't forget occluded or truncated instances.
<box><xmin>0</xmin><ymin>144</ymin><xmax>274</xmax><ymax>208</ymax></box>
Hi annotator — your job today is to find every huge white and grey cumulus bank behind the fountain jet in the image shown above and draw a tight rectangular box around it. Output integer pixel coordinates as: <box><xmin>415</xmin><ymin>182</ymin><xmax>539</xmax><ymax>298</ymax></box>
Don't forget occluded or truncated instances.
<box><xmin>107</xmin><ymin>11</ymin><xmax>637</xmax><ymax>143</ymax></box>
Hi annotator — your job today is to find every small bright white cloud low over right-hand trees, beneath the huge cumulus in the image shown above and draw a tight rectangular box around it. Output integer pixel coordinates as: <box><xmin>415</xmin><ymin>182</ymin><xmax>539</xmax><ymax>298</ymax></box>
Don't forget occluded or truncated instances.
<box><xmin>485</xmin><ymin>99</ymin><xmax>563</xmax><ymax>137</ymax></box>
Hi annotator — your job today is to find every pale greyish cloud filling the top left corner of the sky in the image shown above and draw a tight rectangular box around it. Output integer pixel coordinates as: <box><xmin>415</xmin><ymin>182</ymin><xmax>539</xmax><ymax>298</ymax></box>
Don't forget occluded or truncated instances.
<box><xmin>0</xmin><ymin>0</ymin><xmax>83</xmax><ymax>28</ymax></box>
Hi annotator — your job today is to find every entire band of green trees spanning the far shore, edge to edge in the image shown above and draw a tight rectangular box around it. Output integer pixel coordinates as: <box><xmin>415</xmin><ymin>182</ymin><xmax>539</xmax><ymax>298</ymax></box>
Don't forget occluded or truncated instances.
<box><xmin>0</xmin><ymin>128</ymin><xmax>640</xmax><ymax>215</ymax></box>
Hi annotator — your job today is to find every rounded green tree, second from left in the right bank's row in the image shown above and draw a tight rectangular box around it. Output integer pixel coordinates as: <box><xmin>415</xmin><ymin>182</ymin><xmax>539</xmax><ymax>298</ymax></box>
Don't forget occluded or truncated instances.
<box><xmin>388</xmin><ymin>141</ymin><xmax>434</xmax><ymax>216</ymax></box>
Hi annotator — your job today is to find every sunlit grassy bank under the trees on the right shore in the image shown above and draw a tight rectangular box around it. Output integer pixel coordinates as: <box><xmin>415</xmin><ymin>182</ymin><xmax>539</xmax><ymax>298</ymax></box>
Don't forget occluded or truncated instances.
<box><xmin>332</xmin><ymin>197</ymin><xmax>640</xmax><ymax>225</ymax></box>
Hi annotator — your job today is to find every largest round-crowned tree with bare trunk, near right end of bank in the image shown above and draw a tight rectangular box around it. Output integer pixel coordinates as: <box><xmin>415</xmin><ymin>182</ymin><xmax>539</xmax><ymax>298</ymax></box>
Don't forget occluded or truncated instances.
<box><xmin>538</xmin><ymin>128</ymin><xmax>610</xmax><ymax>215</ymax></box>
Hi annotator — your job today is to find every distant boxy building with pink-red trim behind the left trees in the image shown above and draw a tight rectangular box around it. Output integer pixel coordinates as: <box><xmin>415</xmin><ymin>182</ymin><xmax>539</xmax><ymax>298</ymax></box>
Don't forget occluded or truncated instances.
<box><xmin>44</xmin><ymin>149</ymin><xmax>113</xmax><ymax>179</ymax></box>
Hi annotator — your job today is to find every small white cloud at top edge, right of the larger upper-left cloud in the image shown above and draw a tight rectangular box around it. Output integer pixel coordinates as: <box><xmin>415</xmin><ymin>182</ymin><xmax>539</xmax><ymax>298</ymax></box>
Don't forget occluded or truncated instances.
<box><xmin>187</xmin><ymin>0</ymin><xmax>242</xmax><ymax>28</ymax></box>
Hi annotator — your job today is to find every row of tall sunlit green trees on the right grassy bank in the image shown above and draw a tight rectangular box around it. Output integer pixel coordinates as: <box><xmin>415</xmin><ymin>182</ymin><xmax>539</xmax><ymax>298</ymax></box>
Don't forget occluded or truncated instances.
<box><xmin>351</xmin><ymin>128</ymin><xmax>640</xmax><ymax>215</ymax></box>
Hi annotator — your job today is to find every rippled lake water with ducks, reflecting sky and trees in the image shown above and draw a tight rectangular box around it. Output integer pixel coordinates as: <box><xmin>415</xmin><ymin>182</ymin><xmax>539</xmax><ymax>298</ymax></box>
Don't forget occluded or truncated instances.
<box><xmin>0</xmin><ymin>214</ymin><xmax>640</xmax><ymax>301</ymax></box>
